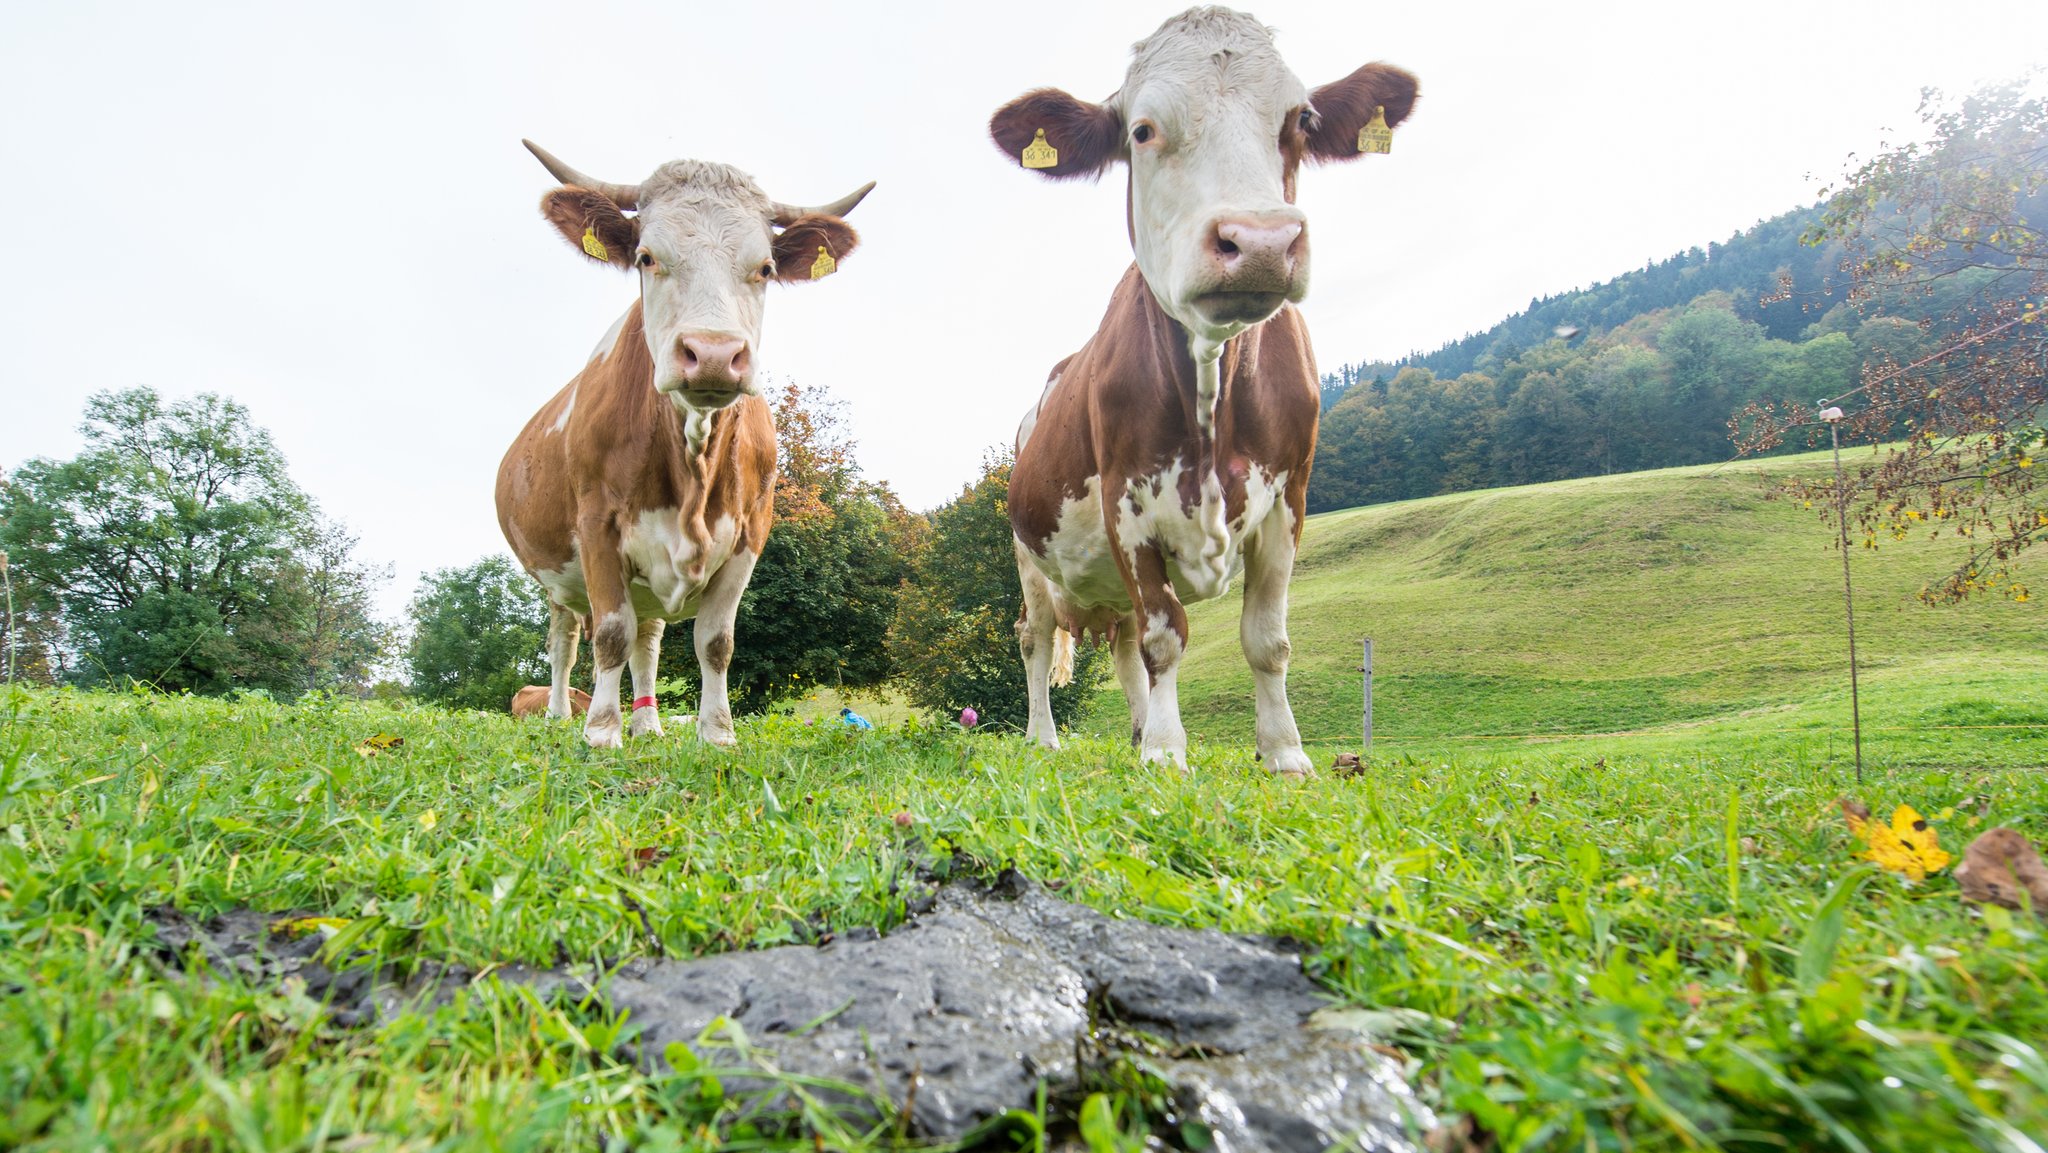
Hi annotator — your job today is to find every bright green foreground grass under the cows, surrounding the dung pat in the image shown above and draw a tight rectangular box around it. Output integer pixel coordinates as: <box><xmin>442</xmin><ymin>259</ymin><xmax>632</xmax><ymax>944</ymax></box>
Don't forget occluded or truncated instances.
<box><xmin>0</xmin><ymin>679</ymin><xmax>2048</xmax><ymax>1151</ymax></box>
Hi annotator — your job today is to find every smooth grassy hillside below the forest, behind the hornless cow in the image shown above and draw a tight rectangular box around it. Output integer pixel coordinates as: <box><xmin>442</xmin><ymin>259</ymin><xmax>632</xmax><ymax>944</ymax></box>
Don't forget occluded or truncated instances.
<box><xmin>1090</xmin><ymin>446</ymin><xmax>2048</xmax><ymax>760</ymax></box>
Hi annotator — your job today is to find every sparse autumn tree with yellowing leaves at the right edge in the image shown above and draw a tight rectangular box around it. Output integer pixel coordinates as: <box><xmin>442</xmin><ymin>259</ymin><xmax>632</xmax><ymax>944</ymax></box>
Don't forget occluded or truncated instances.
<box><xmin>1741</xmin><ymin>74</ymin><xmax>2048</xmax><ymax>602</ymax></box>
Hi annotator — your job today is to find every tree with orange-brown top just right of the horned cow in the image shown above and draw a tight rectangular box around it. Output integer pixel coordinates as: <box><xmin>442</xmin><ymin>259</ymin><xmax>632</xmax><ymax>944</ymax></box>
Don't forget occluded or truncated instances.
<box><xmin>662</xmin><ymin>383</ymin><xmax>924</xmax><ymax>713</ymax></box>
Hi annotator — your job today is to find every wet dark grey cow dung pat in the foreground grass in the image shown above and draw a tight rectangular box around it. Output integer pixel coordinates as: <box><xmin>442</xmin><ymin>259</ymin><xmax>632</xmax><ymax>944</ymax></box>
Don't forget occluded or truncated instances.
<box><xmin>154</xmin><ymin>870</ymin><xmax>1434</xmax><ymax>1153</ymax></box>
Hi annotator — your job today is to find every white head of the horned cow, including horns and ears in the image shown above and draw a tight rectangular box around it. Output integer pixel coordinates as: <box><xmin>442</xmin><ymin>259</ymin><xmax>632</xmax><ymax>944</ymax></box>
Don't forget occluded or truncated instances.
<box><xmin>526</xmin><ymin>141</ymin><xmax>874</xmax><ymax>412</ymax></box>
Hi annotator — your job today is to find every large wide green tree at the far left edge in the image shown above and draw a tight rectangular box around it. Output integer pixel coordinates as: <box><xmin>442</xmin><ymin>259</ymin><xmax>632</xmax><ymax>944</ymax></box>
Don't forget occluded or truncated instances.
<box><xmin>0</xmin><ymin>387</ymin><xmax>385</xmax><ymax>694</ymax></box>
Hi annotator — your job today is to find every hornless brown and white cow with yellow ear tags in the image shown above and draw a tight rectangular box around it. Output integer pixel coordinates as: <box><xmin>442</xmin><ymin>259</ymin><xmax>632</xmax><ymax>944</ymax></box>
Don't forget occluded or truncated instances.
<box><xmin>989</xmin><ymin>8</ymin><xmax>1415</xmax><ymax>774</ymax></box>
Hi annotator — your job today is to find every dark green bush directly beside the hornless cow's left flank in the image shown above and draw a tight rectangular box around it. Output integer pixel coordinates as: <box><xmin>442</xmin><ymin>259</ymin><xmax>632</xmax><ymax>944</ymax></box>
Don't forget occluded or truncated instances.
<box><xmin>889</xmin><ymin>453</ymin><xmax>1108</xmax><ymax>729</ymax></box>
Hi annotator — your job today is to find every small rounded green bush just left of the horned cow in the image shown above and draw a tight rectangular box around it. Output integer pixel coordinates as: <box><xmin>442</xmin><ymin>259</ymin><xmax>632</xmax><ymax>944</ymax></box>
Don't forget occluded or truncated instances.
<box><xmin>406</xmin><ymin>555</ymin><xmax>552</xmax><ymax>713</ymax></box>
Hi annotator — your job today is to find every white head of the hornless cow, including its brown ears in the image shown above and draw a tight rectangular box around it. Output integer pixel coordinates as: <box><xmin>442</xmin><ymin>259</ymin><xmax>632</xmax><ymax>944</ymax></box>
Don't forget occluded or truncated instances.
<box><xmin>989</xmin><ymin>8</ymin><xmax>1415</xmax><ymax>356</ymax></box>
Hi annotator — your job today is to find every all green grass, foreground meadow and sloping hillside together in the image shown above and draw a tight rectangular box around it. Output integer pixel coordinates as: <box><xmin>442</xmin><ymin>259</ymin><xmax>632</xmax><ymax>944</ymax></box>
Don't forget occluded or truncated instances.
<box><xmin>12</xmin><ymin>452</ymin><xmax>2048</xmax><ymax>1153</ymax></box>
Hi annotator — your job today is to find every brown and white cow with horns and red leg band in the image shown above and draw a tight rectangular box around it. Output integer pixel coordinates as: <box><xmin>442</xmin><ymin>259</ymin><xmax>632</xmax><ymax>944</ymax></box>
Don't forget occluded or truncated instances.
<box><xmin>498</xmin><ymin>141</ymin><xmax>874</xmax><ymax>748</ymax></box>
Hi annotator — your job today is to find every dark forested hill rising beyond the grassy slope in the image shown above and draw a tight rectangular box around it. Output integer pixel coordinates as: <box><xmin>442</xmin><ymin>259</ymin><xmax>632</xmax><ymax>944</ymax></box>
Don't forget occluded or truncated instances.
<box><xmin>1309</xmin><ymin>193</ymin><xmax>2023</xmax><ymax>512</ymax></box>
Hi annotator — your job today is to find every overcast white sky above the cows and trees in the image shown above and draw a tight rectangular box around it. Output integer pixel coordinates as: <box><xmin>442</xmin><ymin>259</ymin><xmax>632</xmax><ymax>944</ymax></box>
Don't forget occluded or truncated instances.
<box><xmin>0</xmin><ymin>0</ymin><xmax>2048</xmax><ymax>622</ymax></box>
